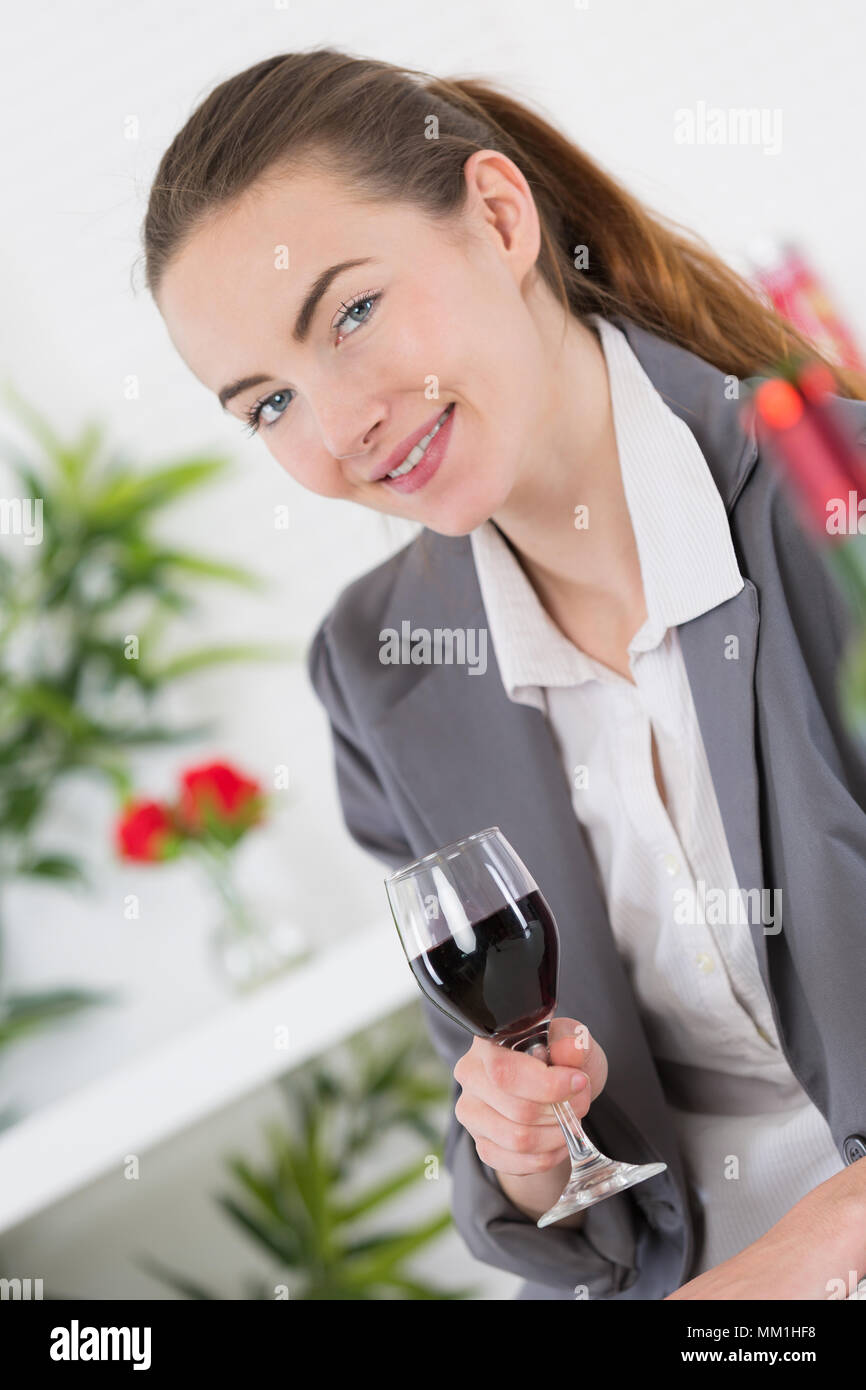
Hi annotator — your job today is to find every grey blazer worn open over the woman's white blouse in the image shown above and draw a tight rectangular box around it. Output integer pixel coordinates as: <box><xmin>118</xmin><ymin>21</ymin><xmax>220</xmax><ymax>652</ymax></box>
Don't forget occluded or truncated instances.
<box><xmin>307</xmin><ymin>318</ymin><xmax>866</xmax><ymax>1300</ymax></box>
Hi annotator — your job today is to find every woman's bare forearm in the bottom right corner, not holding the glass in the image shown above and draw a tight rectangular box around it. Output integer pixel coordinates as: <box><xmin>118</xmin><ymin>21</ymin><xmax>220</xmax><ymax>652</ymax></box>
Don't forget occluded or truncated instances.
<box><xmin>664</xmin><ymin>1159</ymin><xmax>866</xmax><ymax>1301</ymax></box>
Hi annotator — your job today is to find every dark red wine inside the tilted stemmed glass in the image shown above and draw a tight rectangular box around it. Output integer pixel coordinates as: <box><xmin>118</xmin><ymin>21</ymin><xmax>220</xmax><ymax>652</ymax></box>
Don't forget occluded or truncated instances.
<box><xmin>409</xmin><ymin>890</ymin><xmax>559</xmax><ymax>1037</ymax></box>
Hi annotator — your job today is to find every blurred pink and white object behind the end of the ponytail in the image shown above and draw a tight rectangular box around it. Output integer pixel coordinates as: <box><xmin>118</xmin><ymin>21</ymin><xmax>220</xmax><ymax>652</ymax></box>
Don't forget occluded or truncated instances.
<box><xmin>746</xmin><ymin>238</ymin><xmax>866</xmax><ymax>371</ymax></box>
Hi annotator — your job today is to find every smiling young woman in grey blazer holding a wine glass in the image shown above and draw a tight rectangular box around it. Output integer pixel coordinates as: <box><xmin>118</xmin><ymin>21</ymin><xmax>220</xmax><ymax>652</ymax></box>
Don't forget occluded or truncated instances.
<box><xmin>145</xmin><ymin>50</ymin><xmax>866</xmax><ymax>1298</ymax></box>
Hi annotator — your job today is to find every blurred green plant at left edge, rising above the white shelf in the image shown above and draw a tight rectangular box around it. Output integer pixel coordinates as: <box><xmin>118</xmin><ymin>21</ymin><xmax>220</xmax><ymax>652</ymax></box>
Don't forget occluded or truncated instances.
<box><xmin>0</xmin><ymin>385</ymin><xmax>297</xmax><ymax>1045</ymax></box>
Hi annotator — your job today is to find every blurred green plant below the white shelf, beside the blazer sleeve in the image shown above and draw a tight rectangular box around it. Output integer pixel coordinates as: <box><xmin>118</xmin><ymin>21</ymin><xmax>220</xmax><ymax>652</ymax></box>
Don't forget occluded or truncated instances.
<box><xmin>138</xmin><ymin>1004</ymin><xmax>475</xmax><ymax>1301</ymax></box>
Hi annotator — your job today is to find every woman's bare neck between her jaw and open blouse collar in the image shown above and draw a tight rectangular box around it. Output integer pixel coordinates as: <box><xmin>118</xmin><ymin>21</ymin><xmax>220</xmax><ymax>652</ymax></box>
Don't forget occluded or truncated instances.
<box><xmin>492</xmin><ymin>311</ymin><xmax>645</xmax><ymax>626</ymax></box>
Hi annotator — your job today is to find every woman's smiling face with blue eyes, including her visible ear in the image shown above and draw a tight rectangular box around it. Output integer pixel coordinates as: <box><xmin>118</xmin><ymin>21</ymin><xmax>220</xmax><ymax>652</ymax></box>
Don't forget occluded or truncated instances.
<box><xmin>157</xmin><ymin>150</ymin><xmax>553</xmax><ymax>535</ymax></box>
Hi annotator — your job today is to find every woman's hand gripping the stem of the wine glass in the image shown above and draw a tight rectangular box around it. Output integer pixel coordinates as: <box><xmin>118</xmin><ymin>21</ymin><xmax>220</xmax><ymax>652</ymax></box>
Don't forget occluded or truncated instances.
<box><xmin>453</xmin><ymin>1019</ymin><xmax>607</xmax><ymax>1226</ymax></box>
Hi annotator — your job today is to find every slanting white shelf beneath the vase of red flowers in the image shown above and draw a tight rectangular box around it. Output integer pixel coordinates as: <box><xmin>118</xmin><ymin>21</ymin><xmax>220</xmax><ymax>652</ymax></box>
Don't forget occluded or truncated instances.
<box><xmin>0</xmin><ymin>923</ymin><xmax>417</xmax><ymax>1230</ymax></box>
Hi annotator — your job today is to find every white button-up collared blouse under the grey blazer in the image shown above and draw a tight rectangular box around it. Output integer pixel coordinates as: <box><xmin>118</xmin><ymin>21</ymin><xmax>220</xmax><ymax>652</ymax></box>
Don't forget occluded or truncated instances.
<box><xmin>470</xmin><ymin>316</ymin><xmax>861</xmax><ymax>1277</ymax></box>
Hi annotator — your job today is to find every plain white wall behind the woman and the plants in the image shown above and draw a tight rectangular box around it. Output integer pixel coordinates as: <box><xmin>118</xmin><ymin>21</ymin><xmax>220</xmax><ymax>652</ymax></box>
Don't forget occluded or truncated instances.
<box><xmin>0</xmin><ymin>0</ymin><xmax>866</xmax><ymax>1289</ymax></box>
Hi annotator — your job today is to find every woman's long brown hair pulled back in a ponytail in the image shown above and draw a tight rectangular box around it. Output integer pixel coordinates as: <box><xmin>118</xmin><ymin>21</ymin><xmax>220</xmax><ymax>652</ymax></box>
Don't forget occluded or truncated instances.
<box><xmin>142</xmin><ymin>49</ymin><xmax>866</xmax><ymax>399</ymax></box>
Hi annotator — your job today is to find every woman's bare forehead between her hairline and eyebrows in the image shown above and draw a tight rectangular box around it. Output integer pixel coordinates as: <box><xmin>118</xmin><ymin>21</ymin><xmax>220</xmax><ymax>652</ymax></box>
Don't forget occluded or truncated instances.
<box><xmin>157</xmin><ymin>172</ymin><xmax>420</xmax><ymax>391</ymax></box>
